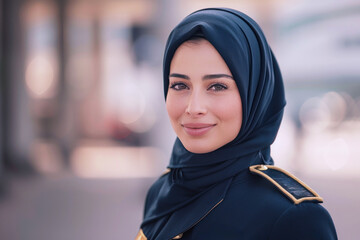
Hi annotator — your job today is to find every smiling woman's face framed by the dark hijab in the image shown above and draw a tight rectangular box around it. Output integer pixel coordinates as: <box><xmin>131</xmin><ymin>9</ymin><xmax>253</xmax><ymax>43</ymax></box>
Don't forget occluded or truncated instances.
<box><xmin>166</xmin><ymin>40</ymin><xmax>242</xmax><ymax>153</ymax></box>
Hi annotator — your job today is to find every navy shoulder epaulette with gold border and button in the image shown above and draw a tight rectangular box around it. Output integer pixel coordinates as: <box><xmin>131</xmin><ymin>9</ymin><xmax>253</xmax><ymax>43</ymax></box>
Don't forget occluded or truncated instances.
<box><xmin>249</xmin><ymin>165</ymin><xmax>323</xmax><ymax>204</ymax></box>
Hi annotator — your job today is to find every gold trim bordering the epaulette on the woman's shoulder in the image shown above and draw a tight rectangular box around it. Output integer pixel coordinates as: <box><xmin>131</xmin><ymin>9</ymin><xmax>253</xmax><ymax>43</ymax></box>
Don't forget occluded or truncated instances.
<box><xmin>249</xmin><ymin>165</ymin><xmax>323</xmax><ymax>204</ymax></box>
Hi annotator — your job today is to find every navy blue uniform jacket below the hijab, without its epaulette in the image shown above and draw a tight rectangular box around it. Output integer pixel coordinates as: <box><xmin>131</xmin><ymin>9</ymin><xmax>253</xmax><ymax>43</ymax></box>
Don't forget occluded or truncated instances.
<box><xmin>138</xmin><ymin>167</ymin><xmax>337</xmax><ymax>240</ymax></box>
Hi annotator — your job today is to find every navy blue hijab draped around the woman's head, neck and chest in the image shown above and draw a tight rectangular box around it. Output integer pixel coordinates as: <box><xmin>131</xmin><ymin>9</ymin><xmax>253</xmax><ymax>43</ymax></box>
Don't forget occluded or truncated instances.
<box><xmin>141</xmin><ymin>8</ymin><xmax>285</xmax><ymax>239</ymax></box>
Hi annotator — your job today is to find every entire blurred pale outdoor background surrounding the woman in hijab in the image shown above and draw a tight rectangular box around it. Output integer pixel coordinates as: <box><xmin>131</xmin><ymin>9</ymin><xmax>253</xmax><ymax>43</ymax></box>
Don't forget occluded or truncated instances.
<box><xmin>0</xmin><ymin>0</ymin><xmax>360</xmax><ymax>240</ymax></box>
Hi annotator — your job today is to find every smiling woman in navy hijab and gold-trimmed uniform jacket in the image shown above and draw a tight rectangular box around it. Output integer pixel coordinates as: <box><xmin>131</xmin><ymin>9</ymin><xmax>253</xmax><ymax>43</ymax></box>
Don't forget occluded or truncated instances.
<box><xmin>136</xmin><ymin>8</ymin><xmax>337</xmax><ymax>240</ymax></box>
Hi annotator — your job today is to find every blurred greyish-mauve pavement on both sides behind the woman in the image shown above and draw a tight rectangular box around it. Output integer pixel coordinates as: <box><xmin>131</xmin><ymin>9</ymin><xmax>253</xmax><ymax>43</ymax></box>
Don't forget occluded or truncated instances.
<box><xmin>0</xmin><ymin>172</ymin><xmax>360</xmax><ymax>240</ymax></box>
